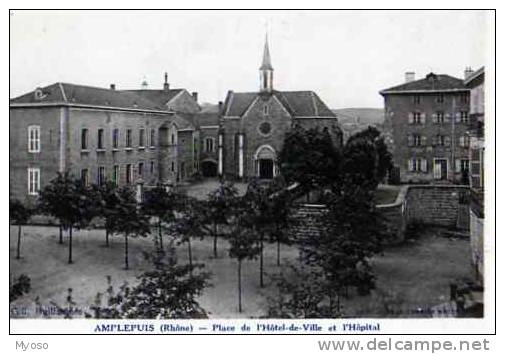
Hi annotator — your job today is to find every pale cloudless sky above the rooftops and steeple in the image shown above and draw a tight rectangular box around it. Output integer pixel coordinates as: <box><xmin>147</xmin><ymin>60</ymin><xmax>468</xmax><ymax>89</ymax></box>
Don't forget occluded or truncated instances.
<box><xmin>10</xmin><ymin>10</ymin><xmax>493</xmax><ymax>109</ymax></box>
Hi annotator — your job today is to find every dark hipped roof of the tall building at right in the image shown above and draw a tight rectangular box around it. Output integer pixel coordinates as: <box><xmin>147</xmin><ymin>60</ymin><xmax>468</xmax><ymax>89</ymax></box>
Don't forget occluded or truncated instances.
<box><xmin>380</xmin><ymin>73</ymin><xmax>467</xmax><ymax>95</ymax></box>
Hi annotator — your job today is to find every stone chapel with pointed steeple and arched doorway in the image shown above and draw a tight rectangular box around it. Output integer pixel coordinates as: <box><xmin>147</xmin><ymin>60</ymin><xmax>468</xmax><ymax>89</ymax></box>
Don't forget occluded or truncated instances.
<box><xmin>218</xmin><ymin>36</ymin><xmax>342</xmax><ymax>179</ymax></box>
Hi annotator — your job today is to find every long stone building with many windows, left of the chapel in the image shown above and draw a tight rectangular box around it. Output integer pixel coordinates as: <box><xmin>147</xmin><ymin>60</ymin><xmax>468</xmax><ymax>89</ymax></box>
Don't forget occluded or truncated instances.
<box><xmin>9</xmin><ymin>79</ymin><xmax>200</xmax><ymax>201</ymax></box>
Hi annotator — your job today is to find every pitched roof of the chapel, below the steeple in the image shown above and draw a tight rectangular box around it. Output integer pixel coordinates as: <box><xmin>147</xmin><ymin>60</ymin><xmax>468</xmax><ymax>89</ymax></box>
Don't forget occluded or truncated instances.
<box><xmin>224</xmin><ymin>91</ymin><xmax>336</xmax><ymax>118</ymax></box>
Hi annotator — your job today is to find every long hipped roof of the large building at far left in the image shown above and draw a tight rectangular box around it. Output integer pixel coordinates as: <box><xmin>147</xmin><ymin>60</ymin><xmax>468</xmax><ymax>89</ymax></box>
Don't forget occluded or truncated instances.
<box><xmin>10</xmin><ymin>83</ymin><xmax>166</xmax><ymax>110</ymax></box>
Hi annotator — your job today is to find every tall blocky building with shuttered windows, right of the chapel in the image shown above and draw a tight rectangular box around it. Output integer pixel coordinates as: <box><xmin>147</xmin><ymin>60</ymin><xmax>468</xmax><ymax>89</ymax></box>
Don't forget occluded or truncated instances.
<box><xmin>380</xmin><ymin>70</ymin><xmax>470</xmax><ymax>183</ymax></box>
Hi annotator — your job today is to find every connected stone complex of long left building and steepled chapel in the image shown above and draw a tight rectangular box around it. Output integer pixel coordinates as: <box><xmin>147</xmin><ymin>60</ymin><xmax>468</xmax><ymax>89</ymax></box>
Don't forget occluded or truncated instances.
<box><xmin>9</xmin><ymin>36</ymin><xmax>342</xmax><ymax>201</ymax></box>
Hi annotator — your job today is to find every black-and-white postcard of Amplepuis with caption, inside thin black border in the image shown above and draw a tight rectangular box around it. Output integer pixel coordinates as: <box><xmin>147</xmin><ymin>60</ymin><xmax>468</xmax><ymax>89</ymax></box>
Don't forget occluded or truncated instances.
<box><xmin>5</xmin><ymin>10</ymin><xmax>495</xmax><ymax>334</ymax></box>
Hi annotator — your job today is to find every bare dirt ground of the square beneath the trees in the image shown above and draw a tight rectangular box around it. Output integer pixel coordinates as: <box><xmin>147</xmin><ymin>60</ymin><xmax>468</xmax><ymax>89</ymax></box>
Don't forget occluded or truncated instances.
<box><xmin>10</xmin><ymin>226</ymin><xmax>472</xmax><ymax>318</ymax></box>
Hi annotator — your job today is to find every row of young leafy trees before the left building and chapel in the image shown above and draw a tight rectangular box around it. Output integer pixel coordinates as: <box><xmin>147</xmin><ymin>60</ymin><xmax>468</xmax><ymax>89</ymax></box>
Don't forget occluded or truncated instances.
<box><xmin>11</xmin><ymin>173</ymin><xmax>290</xmax><ymax>311</ymax></box>
